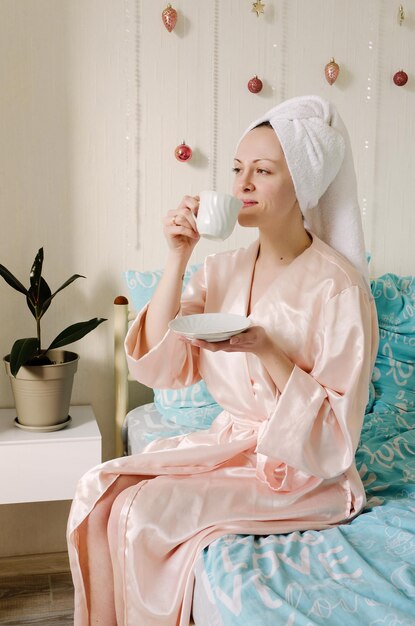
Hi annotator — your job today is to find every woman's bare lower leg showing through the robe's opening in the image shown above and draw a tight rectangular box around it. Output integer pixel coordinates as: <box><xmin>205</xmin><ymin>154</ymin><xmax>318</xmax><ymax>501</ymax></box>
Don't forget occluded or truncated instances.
<box><xmin>79</xmin><ymin>476</ymin><xmax>143</xmax><ymax>626</ymax></box>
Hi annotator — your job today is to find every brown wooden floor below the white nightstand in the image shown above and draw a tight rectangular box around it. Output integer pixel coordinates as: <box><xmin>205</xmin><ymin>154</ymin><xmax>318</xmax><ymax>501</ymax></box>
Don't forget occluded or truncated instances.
<box><xmin>0</xmin><ymin>552</ymin><xmax>73</xmax><ymax>626</ymax></box>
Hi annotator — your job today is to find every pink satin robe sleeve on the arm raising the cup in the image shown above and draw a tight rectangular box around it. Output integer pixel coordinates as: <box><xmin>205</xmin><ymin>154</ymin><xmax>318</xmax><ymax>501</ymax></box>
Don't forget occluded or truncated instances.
<box><xmin>125</xmin><ymin>267</ymin><xmax>206</xmax><ymax>389</ymax></box>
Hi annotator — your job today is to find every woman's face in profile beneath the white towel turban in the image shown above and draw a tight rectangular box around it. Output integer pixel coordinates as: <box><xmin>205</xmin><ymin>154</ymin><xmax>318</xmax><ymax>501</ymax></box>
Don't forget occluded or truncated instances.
<box><xmin>233</xmin><ymin>126</ymin><xmax>299</xmax><ymax>229</ymax></box>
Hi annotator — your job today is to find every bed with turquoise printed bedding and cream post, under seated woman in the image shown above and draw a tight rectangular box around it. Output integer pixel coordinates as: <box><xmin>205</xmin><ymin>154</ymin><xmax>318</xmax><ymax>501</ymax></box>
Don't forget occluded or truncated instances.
<box><xmin>114</xmin><ymin>266</ymin><xmax>415</xmax><ymax>626</ymax></box>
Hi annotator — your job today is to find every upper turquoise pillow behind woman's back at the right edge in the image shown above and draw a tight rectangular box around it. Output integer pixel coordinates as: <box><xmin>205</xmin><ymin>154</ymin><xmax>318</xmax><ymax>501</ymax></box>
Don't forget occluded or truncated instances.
<box><xmin>371</xmin><ymin>274</ymin><xmax>415</xmax><ymax>412</ymax></box>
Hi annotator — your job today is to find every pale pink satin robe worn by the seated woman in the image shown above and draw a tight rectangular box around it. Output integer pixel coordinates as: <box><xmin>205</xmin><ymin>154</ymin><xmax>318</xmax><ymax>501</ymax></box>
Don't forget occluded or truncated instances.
<box><xmin>68</xmin><ymin>236</ymin><xmax>377</xmax><ymax>626</ymax></box>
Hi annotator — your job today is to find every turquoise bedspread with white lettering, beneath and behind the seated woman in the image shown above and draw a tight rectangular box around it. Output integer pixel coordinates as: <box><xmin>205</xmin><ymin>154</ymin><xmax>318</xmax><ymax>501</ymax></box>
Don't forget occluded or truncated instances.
<box><xmin>203</xmin><ymin>411</ymin><xmax>415</xmax><ymax>626</ymax></box>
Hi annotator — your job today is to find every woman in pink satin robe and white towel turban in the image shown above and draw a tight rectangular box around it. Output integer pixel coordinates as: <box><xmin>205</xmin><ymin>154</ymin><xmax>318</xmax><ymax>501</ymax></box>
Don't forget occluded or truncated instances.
<box><xmin>68</xmin><ymin>97</ymin><xmax>377</xmax><ymax>626</ymax></box>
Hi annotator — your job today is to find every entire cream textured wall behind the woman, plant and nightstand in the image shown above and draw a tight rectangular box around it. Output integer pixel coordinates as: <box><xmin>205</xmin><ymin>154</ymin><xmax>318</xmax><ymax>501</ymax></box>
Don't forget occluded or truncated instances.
<box><xmin>0</xmin><ymin>0</ymin><xmax>415</xmax><ymax>554</ymax></box>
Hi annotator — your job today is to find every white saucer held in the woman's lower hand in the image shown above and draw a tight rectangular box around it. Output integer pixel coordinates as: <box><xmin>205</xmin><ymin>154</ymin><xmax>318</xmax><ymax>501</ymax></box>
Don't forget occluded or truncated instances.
<box><xmin>169</xmin><ymin>313</ymin><xmax>251</xmax><ymax>341</ymax></box>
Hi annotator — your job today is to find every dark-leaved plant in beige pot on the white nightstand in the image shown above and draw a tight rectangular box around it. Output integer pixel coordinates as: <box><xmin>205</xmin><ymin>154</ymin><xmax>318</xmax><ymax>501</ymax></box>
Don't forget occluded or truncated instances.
<box><xmin>0</xmin><ymin>248</ymin><xmax>105</xmax><ymax>431</ymax></box>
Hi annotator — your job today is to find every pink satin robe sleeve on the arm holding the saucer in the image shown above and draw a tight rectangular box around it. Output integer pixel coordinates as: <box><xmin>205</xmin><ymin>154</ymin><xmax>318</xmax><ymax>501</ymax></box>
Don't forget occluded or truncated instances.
<box><xmin>257</xmin><ymin>286</ymin><xmax>377</xmax><ymax>479</ymax></box>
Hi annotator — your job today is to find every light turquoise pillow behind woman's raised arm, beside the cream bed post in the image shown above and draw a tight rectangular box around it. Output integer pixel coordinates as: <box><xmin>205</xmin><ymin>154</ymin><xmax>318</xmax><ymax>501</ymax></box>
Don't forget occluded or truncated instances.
<box><xmin>123</xmin><ymin>264</ymin><xmax>222</xmax><ymax>430</ymax></box>
